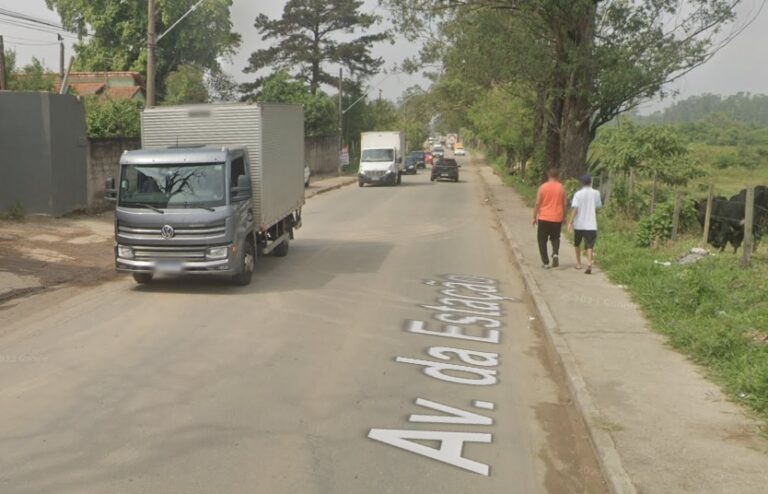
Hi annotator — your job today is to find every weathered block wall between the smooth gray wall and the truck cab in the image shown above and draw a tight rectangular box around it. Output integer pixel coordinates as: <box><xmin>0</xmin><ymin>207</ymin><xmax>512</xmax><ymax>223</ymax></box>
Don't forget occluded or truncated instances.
<box><xmin>88</xmin><ymin>137</ymin><xmax>141</xmax><ymax>209</ymax></box>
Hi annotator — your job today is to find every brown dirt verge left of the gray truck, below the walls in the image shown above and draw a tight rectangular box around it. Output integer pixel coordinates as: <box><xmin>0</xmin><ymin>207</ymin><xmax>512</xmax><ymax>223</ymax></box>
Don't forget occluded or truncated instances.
<box><xmin>0</xmin><ymin>213</ymin><xmax>115</xmax><ymax>303</ymax></box>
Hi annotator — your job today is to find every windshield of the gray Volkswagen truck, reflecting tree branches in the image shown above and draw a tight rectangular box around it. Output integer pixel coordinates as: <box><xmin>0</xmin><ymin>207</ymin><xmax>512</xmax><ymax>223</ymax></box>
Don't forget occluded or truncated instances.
<box><xmin>119</xmin><ymin>163</ymin><xmax>226</xmax><ymax>208</ymax></box>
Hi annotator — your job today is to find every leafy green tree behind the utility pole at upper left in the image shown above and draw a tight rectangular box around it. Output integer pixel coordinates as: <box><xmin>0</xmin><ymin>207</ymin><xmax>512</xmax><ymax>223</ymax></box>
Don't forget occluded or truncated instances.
<box><xmin>45</xmin><ymin>0</ymin><xmax>240</xmax><ymax>99</ymax></box>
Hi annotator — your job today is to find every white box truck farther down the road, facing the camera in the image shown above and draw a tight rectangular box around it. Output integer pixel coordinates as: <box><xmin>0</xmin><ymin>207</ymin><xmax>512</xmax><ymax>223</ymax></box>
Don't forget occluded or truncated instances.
<box><xmin>357</xmin><ymin>131</ymin><xmax>405</xmax><ymax>187</ymax></box>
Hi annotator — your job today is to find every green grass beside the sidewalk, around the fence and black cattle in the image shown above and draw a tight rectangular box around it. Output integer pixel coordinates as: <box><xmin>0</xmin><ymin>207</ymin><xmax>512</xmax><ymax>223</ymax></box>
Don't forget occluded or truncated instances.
<box><xmin>492</xmin><ymin>152</ymin><xmax>768</xmax><ymax>419</ymax></box>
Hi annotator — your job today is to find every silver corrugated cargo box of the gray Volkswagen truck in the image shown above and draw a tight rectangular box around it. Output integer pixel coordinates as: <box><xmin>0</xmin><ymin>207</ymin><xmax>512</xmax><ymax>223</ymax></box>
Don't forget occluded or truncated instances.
<box><xmin>141</xmin><ymin>103</ymin><xmax>304</xmax><ymax>230</ymax></box>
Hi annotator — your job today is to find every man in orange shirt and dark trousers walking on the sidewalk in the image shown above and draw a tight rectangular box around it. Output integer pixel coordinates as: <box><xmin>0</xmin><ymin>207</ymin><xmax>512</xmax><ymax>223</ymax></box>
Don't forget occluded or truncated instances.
<box><xmin>533</xmin><ymin>168</ymin><xmax>568</xmax><ymax>269</ymax></box>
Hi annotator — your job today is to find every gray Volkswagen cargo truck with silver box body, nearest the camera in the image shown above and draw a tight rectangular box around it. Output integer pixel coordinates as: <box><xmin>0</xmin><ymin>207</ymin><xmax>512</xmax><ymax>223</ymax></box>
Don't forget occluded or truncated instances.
<box><xmin>106</xmin><ymin>104</ymin><xmax>304</xmax><ymax>285</ymax></box>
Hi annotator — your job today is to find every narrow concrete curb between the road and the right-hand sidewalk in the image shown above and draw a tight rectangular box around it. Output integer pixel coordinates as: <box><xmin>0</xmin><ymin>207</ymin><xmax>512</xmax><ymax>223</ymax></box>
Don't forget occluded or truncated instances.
<box><xmin>478</xmin><ymin>164</ymin><xmax>637</xmax><ymax>494</ymax></box>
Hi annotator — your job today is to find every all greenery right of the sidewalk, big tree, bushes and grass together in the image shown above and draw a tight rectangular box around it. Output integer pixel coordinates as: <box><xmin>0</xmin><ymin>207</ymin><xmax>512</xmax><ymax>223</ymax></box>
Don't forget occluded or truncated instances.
<box><xmin>385</xmin><ymin>0</ymin><xmax>768</xmax><ymax>418</ymax></box>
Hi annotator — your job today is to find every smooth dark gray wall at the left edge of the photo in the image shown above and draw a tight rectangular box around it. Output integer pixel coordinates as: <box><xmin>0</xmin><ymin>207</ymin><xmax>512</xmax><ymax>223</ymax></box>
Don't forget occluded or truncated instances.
<box><xmin>0</xmin><ymin>91</ymin><xmax>87</xmax><ymax>215</ymax></box>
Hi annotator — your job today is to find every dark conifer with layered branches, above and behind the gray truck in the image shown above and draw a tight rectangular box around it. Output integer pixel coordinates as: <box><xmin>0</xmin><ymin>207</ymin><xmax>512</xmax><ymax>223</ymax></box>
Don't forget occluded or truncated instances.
<box><xmin>245</xmin><ymin>0</ymin><xmax>389</xmax><ymax>95</ymax></box>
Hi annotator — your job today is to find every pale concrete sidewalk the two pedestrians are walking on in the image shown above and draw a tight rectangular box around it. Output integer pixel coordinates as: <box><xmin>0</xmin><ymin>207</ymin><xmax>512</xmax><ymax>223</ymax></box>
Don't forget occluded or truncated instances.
<box><xmin>472</xmin><ymin>160</ymin><xmax>768</xmax><ymax>494</ymax></box>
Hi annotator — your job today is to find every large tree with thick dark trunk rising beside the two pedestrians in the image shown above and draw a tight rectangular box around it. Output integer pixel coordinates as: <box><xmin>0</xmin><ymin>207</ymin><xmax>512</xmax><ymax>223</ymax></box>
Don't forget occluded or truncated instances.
<box><xmin>386</xmin><ymin>0</ymin><xmax>741</xmax><ymax>176</ymax></box>
